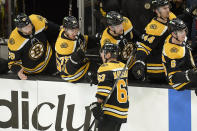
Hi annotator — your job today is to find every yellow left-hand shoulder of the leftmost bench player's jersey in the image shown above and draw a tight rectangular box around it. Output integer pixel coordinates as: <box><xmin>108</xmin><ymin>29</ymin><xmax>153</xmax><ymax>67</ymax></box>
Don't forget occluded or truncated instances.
<box><xmin>8</xmin><ymin>28</ymin><xmax>28</xmax><ymax>51</ymax></box>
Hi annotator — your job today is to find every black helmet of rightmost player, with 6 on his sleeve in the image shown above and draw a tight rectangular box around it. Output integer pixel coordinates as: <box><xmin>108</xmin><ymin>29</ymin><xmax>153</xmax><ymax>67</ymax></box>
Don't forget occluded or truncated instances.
<box><xmin>168</xmin><ymin>18</ymin><xmax>187</xmax><ymax>33</ymax></box>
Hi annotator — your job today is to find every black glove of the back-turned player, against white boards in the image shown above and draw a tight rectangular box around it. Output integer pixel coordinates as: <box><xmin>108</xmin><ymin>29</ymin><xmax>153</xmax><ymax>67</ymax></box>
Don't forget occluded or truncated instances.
<box><xmin>90</xmin><ymin>102</ymin><xmax>103</xmax><ymax>120</ymax></box>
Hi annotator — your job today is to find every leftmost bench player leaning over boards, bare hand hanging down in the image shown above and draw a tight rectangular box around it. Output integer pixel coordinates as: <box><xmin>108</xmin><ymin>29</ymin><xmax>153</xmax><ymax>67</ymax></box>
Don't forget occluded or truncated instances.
<box><xmin>8</xmin><ymin>13</ymin><xmax>60</xmax><ymax>80</ymax></box>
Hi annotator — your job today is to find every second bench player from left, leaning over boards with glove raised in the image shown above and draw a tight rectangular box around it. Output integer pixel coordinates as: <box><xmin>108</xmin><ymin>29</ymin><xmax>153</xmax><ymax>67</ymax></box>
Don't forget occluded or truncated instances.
<box><xmin>55</xmin><ymin>16</ymin><xmax>98</xmax><ymax>83</ymax></box>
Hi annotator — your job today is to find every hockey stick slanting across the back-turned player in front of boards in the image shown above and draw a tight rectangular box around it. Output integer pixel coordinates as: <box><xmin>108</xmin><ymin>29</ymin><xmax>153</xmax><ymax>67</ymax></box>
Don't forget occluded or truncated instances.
<box><xmin>88</xmin><ymin>51</ymin><xmax>135</xmax><ymax>131</ymax></box>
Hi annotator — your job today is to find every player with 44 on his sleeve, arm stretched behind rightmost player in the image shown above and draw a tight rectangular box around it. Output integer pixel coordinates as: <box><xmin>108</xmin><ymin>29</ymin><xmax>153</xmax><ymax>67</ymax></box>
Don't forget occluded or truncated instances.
<box><xmin>133</xmin><ymin>0</ymin><xmax>196</xmax><ymax>82</ymax></box>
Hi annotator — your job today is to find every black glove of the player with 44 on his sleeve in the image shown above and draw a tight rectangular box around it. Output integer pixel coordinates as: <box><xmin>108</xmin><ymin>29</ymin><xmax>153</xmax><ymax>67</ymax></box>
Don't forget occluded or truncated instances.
<box><xmin>132</xmin><ymin>61</ymin><xmax>145</xmax><ymax>81</ymax></box>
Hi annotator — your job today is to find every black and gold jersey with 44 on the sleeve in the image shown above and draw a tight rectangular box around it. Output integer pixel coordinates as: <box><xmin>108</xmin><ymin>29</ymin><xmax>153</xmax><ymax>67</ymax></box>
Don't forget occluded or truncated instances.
<box><xmin>136</xmin><ymin>12</ymin><xmax>176</xmax><ymax>80</ymax></box>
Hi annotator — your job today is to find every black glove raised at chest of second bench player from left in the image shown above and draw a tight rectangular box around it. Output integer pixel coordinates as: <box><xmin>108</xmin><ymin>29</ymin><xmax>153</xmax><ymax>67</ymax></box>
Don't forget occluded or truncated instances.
<box><xmin>71</xmin><ymin>49</ymin><xmax>85</xmax><ymax>64</ymax></box>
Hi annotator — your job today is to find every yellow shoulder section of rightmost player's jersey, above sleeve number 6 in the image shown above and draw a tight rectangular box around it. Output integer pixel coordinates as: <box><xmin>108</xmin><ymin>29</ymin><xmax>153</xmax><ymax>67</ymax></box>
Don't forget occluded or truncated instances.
<box><xmin>163</xmin><ymin>35</ymin><xmax>185</xmax><ymax>59</ymax></box>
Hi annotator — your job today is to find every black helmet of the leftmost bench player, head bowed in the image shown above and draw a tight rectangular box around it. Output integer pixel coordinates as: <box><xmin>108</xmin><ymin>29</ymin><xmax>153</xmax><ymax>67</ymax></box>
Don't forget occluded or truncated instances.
<box><xmin>14</xmin><ymin>13</ymin><xmax>31</xmax><ymax>28</ymax></box>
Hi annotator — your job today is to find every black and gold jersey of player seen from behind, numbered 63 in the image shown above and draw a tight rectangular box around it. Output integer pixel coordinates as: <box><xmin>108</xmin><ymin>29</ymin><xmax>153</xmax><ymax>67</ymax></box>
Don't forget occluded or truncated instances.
<box><xmin>96</xmin><ymin>61</ymin><xmax>129</xmax><ymax>123</ymax></box>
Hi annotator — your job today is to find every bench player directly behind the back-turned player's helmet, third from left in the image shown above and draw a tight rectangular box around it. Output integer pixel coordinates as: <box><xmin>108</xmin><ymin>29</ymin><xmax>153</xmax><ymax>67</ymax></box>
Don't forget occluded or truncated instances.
<box><xmin>100</xmin><ymin>11</ymin><xmax>140</xmax><ymax>79</ymax></box>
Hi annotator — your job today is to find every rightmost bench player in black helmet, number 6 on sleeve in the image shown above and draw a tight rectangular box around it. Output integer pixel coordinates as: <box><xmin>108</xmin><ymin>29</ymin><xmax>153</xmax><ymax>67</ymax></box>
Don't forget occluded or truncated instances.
<box><xmin>162</xmin><ymin>18</ymin><xmax>197</xmax><ymax>90</ymax></box>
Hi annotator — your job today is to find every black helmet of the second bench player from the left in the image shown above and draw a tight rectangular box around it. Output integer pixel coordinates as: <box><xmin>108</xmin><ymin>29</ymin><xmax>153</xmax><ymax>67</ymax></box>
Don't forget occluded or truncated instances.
<box><xmin>63</xmin><ymin>16</ymin><xmax>79</xmax><ymax>29</ymax></box>
